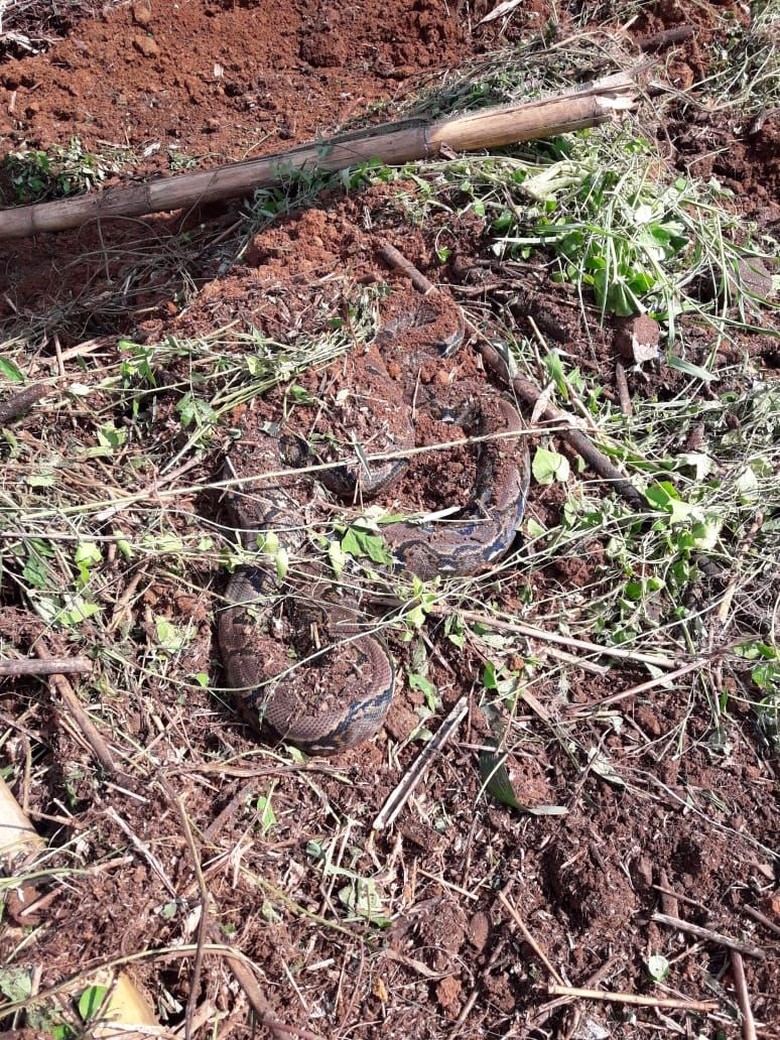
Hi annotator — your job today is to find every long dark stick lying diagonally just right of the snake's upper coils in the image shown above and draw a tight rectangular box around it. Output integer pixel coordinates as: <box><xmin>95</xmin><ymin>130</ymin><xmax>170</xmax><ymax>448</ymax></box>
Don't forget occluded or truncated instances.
<box><xmin>379</xmin><ymin>242</ymin><xmax>647</xmax><ymax>510</ymax></box>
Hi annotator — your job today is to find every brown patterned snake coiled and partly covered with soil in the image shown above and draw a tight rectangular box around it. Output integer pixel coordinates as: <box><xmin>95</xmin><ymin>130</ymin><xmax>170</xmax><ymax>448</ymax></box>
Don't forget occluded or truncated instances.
<box><xmin>217</xmin><ymin>293</ymin><xmax>529</xmax><ymax>754</ymax></box>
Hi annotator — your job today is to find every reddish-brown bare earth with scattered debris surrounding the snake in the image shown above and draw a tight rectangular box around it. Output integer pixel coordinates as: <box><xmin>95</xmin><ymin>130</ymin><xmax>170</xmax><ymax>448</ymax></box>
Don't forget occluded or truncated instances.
<box><xmin>0</xmin><ymin>0</ymin><xmax>780</xmax><ymax>1040</ymax></box>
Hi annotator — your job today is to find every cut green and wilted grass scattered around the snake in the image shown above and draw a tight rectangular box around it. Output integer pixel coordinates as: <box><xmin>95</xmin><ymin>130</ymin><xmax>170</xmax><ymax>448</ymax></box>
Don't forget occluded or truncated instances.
<box><xmin>0</xmin><ymin>12</ymin><xmax>780</xmax><ymax>1035</ymax></box>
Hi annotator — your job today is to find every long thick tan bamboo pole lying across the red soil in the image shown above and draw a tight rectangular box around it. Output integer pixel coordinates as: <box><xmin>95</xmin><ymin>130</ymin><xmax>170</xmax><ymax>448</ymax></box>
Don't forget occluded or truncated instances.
<box><xmin>0</xmin><ymin>73</ymin><xmax>638</xmax><ymax>239</ymax></box>
